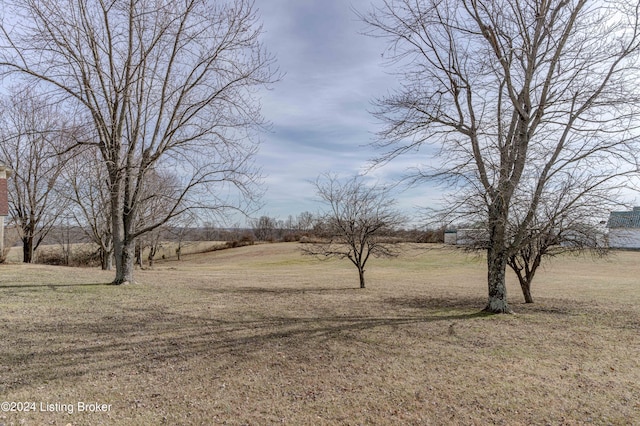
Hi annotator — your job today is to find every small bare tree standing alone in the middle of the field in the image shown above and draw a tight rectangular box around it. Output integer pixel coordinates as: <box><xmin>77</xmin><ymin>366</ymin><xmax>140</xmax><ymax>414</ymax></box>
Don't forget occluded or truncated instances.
<box><xmin>302</xmin><ymin>174</ymin><xmax>405</xmax><ymax>288</ymax></box>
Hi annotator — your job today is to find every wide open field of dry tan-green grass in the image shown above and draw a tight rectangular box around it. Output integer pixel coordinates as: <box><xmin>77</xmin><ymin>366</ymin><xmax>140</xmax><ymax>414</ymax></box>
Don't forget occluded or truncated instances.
<box><xmin>0</xmin><ymin>243</ymin><xmax>640</xmax><ymax>426</ymax></box>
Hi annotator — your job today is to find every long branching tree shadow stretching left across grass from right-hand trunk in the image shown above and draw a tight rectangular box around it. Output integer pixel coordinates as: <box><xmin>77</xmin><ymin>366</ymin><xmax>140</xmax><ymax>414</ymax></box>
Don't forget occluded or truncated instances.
<box><xmin>0</xmin><ymin>294</ymin><xmax>490</xmax><ymax>394</ymax></box>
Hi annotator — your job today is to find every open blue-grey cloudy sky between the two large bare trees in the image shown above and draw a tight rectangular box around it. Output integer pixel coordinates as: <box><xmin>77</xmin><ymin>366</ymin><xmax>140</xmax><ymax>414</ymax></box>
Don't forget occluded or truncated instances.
<box><xmin>248</xmin><ymin>0</ymin><xmax>437</xmax><ymax>225</ymax></box>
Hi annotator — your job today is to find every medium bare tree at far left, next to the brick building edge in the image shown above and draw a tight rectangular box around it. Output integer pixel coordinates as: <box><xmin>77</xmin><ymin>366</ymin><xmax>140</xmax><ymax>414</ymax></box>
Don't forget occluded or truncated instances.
<box><xmin>0</xmin><ymin>87</ymin><xmax>72</xmax><ymax>263</ymax></box>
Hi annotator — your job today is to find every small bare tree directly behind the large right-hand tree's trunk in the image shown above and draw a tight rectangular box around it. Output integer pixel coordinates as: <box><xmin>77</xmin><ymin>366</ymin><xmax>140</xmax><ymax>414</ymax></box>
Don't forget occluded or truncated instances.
<box><xmin>448</xmin><ymin>178</ymin><xmax>619</xmax><ymax>303</ymax></box>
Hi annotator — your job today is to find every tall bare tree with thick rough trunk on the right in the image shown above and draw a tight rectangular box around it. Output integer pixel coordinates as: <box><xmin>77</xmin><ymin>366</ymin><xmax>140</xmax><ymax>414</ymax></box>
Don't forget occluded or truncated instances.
<box><xmin>362</xmin><ymin>0</ymin><xmax>640</xmax><ymax>313</ymax></box>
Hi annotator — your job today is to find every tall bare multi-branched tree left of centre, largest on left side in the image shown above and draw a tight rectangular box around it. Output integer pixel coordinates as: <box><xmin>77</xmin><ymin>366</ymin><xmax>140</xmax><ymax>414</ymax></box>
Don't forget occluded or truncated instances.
<box><xmin>0</xmin><ymin>0</ymin><xmax>277</xmax><ymax>284</ymax></box>
